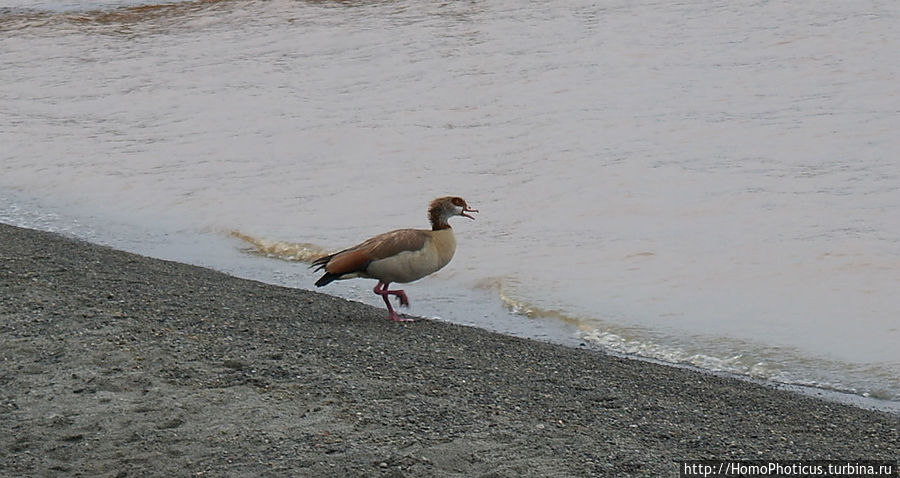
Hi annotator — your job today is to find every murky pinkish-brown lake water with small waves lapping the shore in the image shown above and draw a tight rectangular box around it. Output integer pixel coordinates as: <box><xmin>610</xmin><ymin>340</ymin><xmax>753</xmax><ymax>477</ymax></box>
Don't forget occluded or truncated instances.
<box><xmin>0</xmin><ymin>0</ymin><xmax>900</xmax><ymax>401</ymax></box>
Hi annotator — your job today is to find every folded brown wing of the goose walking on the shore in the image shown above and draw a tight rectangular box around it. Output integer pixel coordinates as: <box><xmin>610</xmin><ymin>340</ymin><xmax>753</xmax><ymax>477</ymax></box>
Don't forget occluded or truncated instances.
<box><xmin>314</xmin><ymin>229</ymin><xmax>429</xmax><ymax>278</ymax></box>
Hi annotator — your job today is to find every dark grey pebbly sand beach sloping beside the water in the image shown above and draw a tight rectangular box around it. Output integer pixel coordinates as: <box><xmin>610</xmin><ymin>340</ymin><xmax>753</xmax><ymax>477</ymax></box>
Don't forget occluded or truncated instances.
<box><xmin>0</xmin><ymin>225</ymin><xmax>900</xmax><ymax>477</ymax></box>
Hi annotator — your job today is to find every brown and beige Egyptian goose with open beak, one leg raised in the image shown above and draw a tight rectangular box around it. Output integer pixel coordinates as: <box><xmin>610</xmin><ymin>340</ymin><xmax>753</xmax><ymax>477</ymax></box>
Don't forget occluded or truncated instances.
<box><xmin>311</xmin><ymin>196</ymin><xmax>478</xmax><ymax>322</ymax></box>
